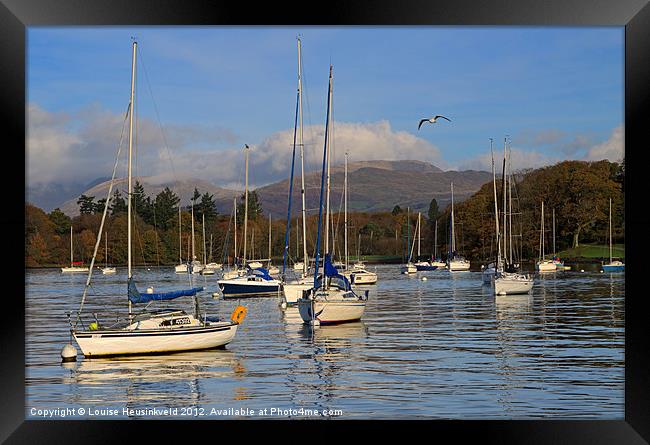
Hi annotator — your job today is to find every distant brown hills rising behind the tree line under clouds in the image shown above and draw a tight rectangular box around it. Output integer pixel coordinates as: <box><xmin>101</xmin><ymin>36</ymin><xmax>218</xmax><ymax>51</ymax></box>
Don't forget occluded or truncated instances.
<box><xmin>61</xmin><ymin>161</ymin><xmax>492</xmax><ymax>217</ymax></box>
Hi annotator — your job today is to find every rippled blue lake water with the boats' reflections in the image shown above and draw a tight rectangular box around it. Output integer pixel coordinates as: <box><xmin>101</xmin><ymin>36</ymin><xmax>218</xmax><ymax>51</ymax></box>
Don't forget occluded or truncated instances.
<box><xmin>25</xmin><ymin>265</ymin><xmax>625</xmax><ymax>419</ymax></box>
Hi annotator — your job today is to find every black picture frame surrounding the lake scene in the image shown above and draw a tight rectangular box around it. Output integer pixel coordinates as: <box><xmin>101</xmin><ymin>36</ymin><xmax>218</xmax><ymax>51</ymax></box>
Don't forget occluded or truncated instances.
<box><xmin>0</xmin><ymin>0</ymin><xmax>650</xmax><ymax>444</ymax></box>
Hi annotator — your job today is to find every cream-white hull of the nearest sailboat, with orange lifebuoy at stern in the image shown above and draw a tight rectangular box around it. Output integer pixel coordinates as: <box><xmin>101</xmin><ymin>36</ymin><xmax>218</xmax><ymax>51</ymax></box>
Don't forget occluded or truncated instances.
<box><xmin>72</xmin><ymin>323</ymin><xmax>238</xmax><ymax>358</ymax></box>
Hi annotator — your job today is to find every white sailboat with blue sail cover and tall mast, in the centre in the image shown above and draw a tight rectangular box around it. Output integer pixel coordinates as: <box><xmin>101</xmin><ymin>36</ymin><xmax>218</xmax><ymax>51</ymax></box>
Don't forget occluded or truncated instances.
<box><xmin>298</xmin><ymin>65</ymin><xmax>368</xmax><ymax>325</ymax></box>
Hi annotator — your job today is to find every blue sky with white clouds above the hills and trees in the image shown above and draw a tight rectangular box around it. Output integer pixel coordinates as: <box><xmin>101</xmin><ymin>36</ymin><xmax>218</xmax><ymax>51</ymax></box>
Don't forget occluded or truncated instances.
<box><xmin>26</xmin><ymin>26</ymin><xmax>624</xmax><ymax>201</ymax></box>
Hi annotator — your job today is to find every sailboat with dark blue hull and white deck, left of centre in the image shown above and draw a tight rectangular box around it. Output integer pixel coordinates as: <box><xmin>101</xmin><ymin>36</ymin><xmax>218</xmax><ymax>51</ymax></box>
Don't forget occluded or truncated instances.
<box><xmin>217</xmin><ymin>145</ymin><xmax>280</xmax><ymax>298</ymax></box>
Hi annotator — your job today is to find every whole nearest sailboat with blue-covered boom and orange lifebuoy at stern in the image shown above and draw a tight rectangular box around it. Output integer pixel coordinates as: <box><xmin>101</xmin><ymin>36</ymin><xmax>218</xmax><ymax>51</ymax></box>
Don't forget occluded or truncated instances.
<box><xmin>69</xmin><ymin>41</ymin><xmax>246</xmax><ymax>358</ymax></box>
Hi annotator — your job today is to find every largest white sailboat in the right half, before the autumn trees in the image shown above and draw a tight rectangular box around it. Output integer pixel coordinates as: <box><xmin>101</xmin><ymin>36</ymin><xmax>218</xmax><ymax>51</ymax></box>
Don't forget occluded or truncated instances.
<box><xmin>482</xmin><ymin>139</ymin><xmax>533</xmax><ymax>295</ymax></box>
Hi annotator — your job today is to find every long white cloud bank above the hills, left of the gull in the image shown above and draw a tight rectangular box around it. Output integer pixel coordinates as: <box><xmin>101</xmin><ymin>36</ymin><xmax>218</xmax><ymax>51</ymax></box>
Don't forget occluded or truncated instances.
<box><xmin>27</xmin><ymin>104</ymin><xmax>442</xmax><ymax>188</ymax></box>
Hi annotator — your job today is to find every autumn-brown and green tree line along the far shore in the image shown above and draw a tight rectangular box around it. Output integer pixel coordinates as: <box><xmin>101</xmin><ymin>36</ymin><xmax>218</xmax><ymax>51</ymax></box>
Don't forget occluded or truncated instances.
<box><xmin>25</xmin><ymin>161</ymin><xmax>625</xmax><ymax>267</ymax></box>
